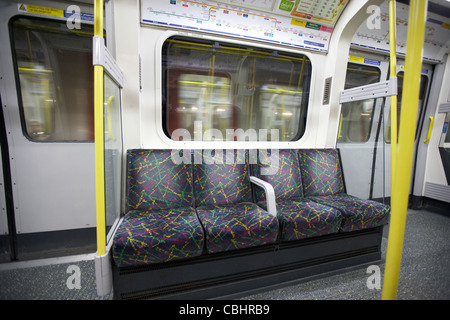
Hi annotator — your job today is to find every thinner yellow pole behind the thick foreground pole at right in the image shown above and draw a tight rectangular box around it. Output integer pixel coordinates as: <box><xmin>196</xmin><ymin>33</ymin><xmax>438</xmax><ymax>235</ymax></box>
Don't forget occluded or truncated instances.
<box><xmin>389</xmin><ymin>0</ymin><xmax>398</xmax><ymax>180</ymax></box>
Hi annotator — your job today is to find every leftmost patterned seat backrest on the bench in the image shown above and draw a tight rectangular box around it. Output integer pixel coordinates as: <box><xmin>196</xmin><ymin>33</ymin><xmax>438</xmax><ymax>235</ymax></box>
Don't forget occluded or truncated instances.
<box><xmin>126</xmin><ymin>149</ymin><xmax>194</xmax><ymax>211</ymax></box>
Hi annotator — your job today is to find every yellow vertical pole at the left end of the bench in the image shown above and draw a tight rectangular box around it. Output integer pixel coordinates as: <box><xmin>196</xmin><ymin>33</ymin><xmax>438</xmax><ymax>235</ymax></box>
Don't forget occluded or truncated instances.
<box><xmin>94</xmin><ymin>0</ymin><xmax>106</xmax><ymax>256</ymax></box>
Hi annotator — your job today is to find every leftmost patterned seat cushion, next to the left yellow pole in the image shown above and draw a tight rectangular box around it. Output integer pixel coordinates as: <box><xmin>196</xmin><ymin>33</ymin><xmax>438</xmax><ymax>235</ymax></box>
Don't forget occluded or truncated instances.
<box><xmin>112</xmin><ymin>207</ymin><xmax>204</xmax><ymax>267</ymax></box>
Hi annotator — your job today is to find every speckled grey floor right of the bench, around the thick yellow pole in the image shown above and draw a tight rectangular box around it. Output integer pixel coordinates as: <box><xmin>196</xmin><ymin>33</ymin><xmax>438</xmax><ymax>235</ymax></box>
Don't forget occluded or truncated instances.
<box><xmin>242</xmin><ymin>210</ymin><xmax>450</xmax><ymax>300</ymax></box>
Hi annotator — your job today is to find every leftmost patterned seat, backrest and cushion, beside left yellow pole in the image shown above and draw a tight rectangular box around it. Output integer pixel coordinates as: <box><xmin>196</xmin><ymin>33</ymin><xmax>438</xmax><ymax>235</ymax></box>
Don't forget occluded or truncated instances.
<box><xmin>112</xmin><ymin>150</ymin><xmax>204</xmax><ymax>267</ymax></box>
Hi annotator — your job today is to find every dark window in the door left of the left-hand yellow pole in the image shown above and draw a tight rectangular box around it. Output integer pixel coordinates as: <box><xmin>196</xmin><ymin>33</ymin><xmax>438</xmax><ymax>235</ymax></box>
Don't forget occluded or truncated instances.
<box><xmin>10</xmin><ymin>17</ymin><xmax>94</xmax><ymax>142</ymax></box>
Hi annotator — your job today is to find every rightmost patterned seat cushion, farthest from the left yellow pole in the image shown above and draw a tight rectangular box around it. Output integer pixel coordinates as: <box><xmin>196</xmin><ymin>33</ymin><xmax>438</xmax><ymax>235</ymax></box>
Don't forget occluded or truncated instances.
<box><xmin>310</xmin><ymin>193</ymin><xmax>390</xmax><ymax>231</ymax></box>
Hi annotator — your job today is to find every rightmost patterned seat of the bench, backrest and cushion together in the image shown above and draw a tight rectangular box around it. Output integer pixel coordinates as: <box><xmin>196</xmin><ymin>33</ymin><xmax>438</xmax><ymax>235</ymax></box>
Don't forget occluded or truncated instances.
<box><xmin>298</xmin><ymin>149</ymin><xmax>390</xmax><ymax>231</ymax></box>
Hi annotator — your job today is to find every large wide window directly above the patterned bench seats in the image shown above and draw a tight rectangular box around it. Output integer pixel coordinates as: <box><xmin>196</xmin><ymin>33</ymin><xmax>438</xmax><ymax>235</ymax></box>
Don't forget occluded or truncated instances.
<box><xmin>162</xmin><ymin>36</ymin><xmax>311</xmax><ymax>141</ymax></box>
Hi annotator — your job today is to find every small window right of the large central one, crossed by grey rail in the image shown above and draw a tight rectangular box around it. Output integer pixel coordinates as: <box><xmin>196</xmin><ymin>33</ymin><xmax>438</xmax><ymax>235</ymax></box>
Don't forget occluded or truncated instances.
<box><xmin>338</xmin><ymin>63</ymin><xmax>381</xmax><ymax>142</ymax></box>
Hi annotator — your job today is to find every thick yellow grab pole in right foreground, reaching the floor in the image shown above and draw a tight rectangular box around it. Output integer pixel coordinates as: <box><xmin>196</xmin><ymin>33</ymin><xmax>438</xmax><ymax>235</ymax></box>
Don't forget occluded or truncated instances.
<box><xmin>382</xmin><ymin>0</ymin><xmax>428</xmax><ymax>300</ymax></box>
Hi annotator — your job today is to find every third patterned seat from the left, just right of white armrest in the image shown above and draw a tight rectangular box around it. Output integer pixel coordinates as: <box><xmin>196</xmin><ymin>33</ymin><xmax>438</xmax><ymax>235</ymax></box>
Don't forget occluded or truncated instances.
<box><xmin>254</xmin><ymin>150</ymin><xmax>341</xmax><ymax>241</ymax></box>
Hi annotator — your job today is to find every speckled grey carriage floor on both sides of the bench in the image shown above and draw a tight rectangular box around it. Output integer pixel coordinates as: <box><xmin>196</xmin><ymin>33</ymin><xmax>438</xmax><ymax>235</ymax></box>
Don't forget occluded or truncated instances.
<box><xmin>0</xmin><ymin>210</ymin><xmax>450</xmax><ymax>300</ymax></box>
